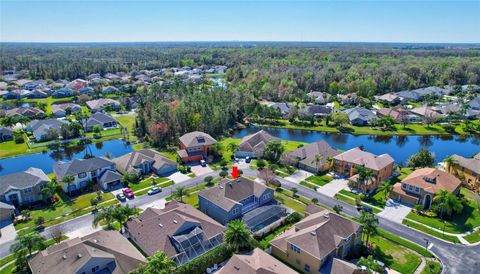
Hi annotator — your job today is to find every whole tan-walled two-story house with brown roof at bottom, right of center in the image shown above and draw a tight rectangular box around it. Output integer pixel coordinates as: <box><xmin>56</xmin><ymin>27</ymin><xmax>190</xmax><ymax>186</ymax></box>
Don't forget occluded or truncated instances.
<box><xmin>270</xmin><ymin>204</ymin><xmax>362</xmax><ymax>273</ymax></box>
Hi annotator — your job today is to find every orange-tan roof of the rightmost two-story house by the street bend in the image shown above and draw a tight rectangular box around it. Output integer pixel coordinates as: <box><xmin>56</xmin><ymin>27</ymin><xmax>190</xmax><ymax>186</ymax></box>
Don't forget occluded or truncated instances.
<box><xmin>402</xmin><ymin>168</ymin><xmax>462</xmax><ymax>193</ymax></box>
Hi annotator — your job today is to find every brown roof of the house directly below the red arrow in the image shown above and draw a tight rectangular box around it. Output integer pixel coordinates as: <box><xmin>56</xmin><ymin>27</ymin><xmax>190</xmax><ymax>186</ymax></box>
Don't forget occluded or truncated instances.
<box><xmin>198</xmin><ymin>177</ymin><xmax>268</xmax><ymax>211</ymax></box>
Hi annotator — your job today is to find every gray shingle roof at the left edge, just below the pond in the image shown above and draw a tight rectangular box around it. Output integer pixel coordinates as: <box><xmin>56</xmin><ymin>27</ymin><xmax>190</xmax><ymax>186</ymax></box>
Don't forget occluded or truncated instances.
<box><xmin>0</xmin><ymin>167</ymin><xmax>50</xmax><ymax>193</ymax></box>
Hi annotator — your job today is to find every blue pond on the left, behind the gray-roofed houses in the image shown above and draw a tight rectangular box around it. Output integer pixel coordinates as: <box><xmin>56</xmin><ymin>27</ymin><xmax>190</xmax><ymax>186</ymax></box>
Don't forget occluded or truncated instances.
<box><xmin>0</xmin><ymin>139</ymin><xmax>132</xmax><ymax>176</ymax></box>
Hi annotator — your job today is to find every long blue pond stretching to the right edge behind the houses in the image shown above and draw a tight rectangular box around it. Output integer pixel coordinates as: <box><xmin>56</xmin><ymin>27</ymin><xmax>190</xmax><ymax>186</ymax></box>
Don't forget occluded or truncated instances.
<box><xmin>233</xmin><ymin>126</ymin><xmax>480</xmax><ymax>164</ymax></box>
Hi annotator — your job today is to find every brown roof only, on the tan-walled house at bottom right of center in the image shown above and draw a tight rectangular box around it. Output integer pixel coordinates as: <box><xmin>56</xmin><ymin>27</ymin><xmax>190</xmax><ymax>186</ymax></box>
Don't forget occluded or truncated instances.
<box><xmin>271</xmin><ymin>210</ymin><xmax>361</xmax><ymax>259</ymax></box>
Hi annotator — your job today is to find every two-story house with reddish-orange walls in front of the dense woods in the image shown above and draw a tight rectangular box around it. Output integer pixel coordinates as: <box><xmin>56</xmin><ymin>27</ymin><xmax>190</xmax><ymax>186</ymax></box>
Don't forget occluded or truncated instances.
<box><xmin>177</xmin><ymin>131</ymin><xmax>217</xmax><ymax>163</ymax></box>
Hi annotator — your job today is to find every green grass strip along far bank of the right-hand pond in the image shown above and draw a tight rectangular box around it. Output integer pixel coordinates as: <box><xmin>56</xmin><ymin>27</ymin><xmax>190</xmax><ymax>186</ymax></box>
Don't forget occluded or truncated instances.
<box><xmin>258</xmin><ymin>120</ymin><xmax>480</xmax><ymax>136</ymax></box>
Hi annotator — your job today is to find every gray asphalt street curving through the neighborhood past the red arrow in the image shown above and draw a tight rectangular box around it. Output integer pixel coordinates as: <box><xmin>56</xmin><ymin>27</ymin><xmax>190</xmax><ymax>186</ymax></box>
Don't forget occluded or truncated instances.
<box><xmin>0</xmin><ymin>169</ymin><xmax>480</xmax><ymax>273</ymax></box>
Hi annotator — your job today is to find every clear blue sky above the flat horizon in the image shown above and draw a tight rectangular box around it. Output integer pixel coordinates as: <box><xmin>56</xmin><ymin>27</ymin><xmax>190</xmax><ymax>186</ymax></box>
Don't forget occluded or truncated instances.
<box><xmin>0</xmin><ymin>0</ymin><xmax>480</xmax><ymax>43</ymax></box>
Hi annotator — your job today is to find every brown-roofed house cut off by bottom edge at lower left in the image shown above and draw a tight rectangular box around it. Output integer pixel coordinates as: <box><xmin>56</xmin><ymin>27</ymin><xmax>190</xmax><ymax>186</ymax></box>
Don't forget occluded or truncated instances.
<box><xmin>28</xmin><ymin>230</ymin><xmax>146</xmax><ymax>274</ymax></box>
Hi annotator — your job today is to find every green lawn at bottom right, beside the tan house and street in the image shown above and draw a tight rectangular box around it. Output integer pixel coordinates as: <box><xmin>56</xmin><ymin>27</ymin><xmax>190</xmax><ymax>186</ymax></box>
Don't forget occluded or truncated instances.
<box><xmin>371</xmin><ymin>233</ymin><xmax>422</xmax><ymax>273</ymax></box>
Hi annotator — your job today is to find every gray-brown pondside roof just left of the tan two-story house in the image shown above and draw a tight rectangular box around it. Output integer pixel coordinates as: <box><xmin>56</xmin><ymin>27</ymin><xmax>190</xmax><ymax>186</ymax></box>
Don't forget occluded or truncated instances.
<box><xmin>284</xmin><ymin>141</ymin><xmax>340</xmax><ymax>168</ymax></box>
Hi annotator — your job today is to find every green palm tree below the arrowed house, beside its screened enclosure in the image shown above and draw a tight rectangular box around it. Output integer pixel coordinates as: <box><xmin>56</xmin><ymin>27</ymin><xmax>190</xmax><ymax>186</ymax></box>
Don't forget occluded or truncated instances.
<box><xmin>223</xmin><ymin>220</ymin><xmax>253</xmax><ymax>252</ymax></box>
